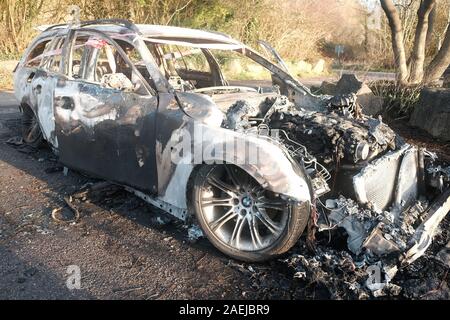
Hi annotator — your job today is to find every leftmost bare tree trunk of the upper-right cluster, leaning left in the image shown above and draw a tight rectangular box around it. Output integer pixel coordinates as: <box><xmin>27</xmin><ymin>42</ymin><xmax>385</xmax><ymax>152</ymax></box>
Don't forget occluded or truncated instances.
<box><xmin>380</xmin><ymin>0</ymin><xmax>408</xmax><ymax>84</ymax></box>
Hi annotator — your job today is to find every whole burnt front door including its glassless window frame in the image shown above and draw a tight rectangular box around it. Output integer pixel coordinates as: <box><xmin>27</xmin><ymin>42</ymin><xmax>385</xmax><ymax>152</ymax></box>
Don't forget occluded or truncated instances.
<box><xmin>54</xmin><ymin>31</ymin><xmax>157</xmax><ymax>192</ymax></box>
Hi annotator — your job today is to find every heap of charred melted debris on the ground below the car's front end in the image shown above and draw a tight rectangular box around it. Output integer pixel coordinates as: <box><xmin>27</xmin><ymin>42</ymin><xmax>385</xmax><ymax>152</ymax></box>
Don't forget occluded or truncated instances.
<box><xmin>227</xmin><ymin>212</ymin><xmax>450</xmax><ymax>300</ymax></box>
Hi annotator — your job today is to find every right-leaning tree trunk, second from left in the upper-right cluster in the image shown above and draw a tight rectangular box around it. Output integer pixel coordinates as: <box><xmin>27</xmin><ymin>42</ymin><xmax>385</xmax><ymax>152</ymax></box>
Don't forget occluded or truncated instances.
<box><xmin>409</xmin><ymin>0</ymin><xmax>436</xmax><ymax>84</ymax></box>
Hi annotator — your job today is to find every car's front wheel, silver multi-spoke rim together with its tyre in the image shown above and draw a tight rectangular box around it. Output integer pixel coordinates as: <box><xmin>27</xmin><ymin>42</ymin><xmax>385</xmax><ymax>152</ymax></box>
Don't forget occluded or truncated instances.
<box><xmin>192</xmin><ymin>165</ymin><xmax>310</xmax><ymax>262</ymax></box>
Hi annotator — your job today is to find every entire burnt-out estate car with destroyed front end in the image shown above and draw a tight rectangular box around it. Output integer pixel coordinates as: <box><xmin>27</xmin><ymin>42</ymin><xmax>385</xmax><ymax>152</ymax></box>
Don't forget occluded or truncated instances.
<box><xmin>15</xmin><ymin>20</ymin><xmax>450</xmax><ymax>266</ymax></box>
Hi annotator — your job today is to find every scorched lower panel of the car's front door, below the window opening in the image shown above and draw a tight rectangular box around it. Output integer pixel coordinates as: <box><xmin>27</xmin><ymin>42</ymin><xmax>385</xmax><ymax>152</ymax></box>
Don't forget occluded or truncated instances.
<box><xmin>55</xmin><ymin>80</ymin><xmax>157</xmax><ymax>193</ymax></box>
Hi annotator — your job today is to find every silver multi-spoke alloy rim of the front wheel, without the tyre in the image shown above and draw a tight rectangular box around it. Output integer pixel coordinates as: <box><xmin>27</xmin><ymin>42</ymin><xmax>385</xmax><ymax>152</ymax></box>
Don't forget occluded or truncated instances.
<box><xmin>200</xmin><ymin>165</ymin><xmax>290</xmax><ymax>252</ymax></box>
